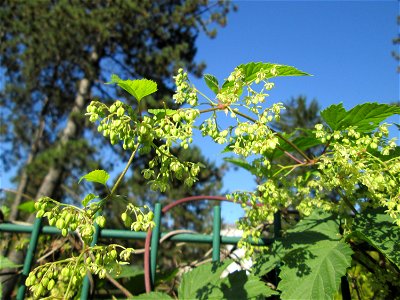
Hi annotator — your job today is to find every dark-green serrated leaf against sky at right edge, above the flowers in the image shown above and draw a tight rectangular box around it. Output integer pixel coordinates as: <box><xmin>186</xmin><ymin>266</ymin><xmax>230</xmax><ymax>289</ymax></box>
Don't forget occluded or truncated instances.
<box><xmin>321</xmin><ymin>103</ymin><xmax>400</xmax><ymax>132</ymax></box>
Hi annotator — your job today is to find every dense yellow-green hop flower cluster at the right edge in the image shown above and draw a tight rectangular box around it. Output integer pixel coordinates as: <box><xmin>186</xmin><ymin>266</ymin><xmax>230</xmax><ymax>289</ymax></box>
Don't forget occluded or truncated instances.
<box><xmin>297</xmin><ymin>124</ymin><xmax>400</xmax><ymax>225</ymax></box>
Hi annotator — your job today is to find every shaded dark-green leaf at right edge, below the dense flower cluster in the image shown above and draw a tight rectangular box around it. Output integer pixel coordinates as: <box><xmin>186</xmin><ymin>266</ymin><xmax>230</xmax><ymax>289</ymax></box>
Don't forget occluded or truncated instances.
<box><xmin>346</xmin><ymin>209</ymin><xmax>400</xmax><ymax>268</ymax></box>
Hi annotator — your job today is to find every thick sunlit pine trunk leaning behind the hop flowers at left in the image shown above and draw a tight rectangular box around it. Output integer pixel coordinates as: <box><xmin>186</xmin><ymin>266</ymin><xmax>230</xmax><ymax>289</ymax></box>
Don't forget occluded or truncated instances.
<box><xmin>1</xmin><ymin>78</ymin><xmax>91</xmax><ymax>299</ymax></box>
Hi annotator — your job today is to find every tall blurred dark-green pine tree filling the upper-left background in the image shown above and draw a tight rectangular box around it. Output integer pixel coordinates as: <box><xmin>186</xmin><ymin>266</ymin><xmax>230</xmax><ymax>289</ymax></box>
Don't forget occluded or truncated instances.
<box><xmin>0</xmin><ymin>0</ymin><xmax>234</xmax><ymax>298</ymax></box>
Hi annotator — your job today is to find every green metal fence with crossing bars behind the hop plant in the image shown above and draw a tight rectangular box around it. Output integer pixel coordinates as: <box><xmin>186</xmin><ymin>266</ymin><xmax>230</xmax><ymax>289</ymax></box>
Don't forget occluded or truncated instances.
<box><xmin>0</xmin><ymin>196</ymin><xmax>281</xmax><ymax>300</ymax></box>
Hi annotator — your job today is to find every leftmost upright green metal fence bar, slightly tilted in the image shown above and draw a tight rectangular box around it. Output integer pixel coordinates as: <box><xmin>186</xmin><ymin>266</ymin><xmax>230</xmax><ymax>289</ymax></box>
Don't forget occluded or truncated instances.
<box><xmin>17</xmin><ymin>218</ymin><xmax>42</xmax><ymax>300</ymax></box>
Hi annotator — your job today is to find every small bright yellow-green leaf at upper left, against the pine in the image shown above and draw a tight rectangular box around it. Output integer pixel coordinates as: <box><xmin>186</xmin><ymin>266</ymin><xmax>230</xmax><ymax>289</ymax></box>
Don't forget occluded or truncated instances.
<box><xmin>107</xmin><ymin>74</ymin><xmax>157</xmax><ymax>102</ymax></box>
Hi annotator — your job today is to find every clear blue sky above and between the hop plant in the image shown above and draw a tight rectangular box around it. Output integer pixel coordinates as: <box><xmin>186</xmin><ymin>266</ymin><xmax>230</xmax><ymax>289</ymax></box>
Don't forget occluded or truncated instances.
<box><xmin>192</xmin><ymin>1</ymin><xmax>399</xmax><ymax>221</ymax></box>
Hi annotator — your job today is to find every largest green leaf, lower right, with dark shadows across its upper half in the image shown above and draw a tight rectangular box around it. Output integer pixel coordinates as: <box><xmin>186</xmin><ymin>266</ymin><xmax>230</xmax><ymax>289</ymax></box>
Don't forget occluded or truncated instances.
<box><xmin>278</xmin><ymin>210</ymin><xmax>353</xmax><ymax>299</ymax></box>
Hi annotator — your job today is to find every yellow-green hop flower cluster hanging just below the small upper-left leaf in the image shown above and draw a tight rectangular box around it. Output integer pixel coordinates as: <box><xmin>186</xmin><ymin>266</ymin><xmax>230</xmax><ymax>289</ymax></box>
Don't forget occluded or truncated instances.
<box><xmin>87</xmin><ymin>98</ymin><xmax>200</xmax><ymax>192</ymax></box>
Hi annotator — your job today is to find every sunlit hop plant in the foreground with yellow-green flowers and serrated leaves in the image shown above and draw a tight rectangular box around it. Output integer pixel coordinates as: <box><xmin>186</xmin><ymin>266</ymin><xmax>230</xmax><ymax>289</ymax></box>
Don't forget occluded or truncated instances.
<box><xmin>4</xmin><ymin>63</ymin><xmax>400</xmax><ymax>299</ymax></box>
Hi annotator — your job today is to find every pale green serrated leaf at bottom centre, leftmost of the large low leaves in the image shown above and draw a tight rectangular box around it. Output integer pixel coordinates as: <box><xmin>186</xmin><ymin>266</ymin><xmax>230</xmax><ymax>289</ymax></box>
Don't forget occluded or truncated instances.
<box><xmin>178</xmin><ymin>260</ymin><xmax>232</xmax><ymax>299</ymax></box>
